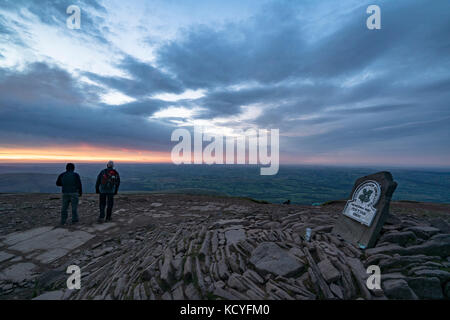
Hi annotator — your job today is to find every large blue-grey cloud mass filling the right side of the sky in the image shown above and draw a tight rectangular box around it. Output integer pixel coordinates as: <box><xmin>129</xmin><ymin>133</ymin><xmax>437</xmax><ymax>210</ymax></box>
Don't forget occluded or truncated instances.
<box><xmin>155</xmin><ymin>1</ymin><xmax>450</xmax><ymax>162</ymax></box>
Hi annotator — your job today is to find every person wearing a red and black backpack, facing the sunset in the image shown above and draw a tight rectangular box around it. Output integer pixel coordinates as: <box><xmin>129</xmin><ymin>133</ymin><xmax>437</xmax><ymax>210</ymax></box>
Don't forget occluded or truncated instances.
<box><xmin>95</xmin><ymin>161</ymin><xmax>120</xmax><ymax>223</ymax></box>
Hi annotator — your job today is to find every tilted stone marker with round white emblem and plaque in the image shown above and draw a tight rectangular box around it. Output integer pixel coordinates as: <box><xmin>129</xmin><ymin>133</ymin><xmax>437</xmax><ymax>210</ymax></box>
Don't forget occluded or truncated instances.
<box><xmin>332</xmin><ymin>171</ymin><xmax>397</xmax><ymax>248</ymax></box>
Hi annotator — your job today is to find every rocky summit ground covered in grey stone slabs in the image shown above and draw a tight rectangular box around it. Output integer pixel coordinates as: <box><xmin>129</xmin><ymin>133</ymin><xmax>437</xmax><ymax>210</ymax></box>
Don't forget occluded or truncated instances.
<box><xmin>0</xmin><ymin>194</ymin><xmax>450</xmax><ymax>300</ymax></box>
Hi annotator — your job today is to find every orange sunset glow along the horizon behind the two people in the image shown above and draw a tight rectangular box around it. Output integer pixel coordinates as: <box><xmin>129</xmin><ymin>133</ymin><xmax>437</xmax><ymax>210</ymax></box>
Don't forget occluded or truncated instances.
<box><xmin>0</xmin><ymin>145</ymin><xmax>170</xmax><ymax>163</ymax></box>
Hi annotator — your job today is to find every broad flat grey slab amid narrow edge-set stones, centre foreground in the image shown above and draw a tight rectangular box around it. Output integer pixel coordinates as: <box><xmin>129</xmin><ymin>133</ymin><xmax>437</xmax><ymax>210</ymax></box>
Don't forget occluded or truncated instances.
<box><xmin>250</xmin><ymin>242</ymin><xmax>304</xmax><ymax>276</ymax></box>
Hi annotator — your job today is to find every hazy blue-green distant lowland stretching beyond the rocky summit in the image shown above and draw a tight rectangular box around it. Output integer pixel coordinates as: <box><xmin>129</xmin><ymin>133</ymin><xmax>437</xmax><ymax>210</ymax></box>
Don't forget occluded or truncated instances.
<box><xmin>0</xmin><ymin>164</ymin><xmax>450</xmax><ymax>204</ymax></box>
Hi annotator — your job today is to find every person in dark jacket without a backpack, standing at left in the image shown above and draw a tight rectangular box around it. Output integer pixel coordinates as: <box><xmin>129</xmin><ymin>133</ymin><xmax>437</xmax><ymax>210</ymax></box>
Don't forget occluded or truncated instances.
<box><xmin>56</xmin><ymin>163</ymin><xmax>83</xmax><ymax>225</ymax></box>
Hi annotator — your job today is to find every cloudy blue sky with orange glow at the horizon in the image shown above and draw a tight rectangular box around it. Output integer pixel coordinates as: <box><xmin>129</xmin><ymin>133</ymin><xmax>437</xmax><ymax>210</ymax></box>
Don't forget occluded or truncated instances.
<box><xmin>0</xmin><ymin>0</ymin><xmax>450</xmax><ymax>167</ymax></box>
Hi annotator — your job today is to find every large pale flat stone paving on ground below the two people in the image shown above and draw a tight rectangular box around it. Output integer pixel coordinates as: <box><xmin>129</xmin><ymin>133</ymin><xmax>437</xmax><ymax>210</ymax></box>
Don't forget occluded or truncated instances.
<box><xmin>8</xmin><ymin>227</ymin><xmax>95</xmax><ymax>263</ymax></box>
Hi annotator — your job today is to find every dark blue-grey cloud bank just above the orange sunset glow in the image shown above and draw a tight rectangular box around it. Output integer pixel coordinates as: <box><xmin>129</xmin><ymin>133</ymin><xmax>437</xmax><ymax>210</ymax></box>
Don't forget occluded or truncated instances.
<box><xmin>0</xmin><ymin>63</ymin><xmax>172</xmax><ymax>151</ymax></box>
